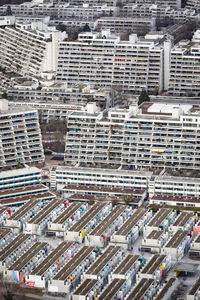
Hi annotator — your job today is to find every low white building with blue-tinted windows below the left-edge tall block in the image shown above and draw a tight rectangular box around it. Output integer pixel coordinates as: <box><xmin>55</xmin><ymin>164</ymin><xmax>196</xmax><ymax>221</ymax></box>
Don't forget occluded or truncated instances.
<box><xmin>0</xmin><ymin>167</ymin><xmax>41</xmax><ymax>191</ymax></box>
